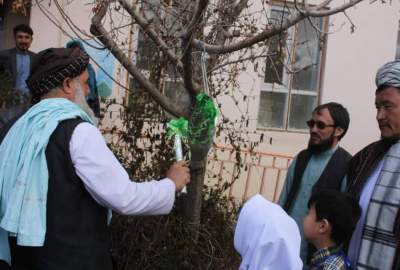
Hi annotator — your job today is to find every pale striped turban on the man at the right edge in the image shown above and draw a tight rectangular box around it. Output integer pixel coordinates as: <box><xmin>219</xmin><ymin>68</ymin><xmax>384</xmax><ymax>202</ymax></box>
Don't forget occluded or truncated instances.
<box><xmin>375</xmin><ymin>60</ymin><xmax>400</xmax><ymax>87</ymax></box>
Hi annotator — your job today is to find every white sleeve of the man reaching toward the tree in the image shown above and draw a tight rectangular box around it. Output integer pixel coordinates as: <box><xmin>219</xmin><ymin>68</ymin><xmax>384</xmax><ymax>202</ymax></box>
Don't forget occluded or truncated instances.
<box><xmin>69</xmin><ymin>123</ymin><xmax>175</xmax><ymax>215</ymax></box>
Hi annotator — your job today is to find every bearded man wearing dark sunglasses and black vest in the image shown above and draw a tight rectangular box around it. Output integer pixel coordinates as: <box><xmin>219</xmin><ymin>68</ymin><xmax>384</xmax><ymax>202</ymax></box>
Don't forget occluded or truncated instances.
<box><xmin>278</xmin><ymin>102</ymin><xmax>351</xmax><ymax>265</ymax></box>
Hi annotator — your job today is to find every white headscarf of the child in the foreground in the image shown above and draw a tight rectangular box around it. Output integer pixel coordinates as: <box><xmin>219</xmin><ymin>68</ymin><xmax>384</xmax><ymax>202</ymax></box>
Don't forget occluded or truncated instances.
<box><xmin>234</xmin><ymin>195</ymin><xmax>303</xmax><ymax>270</ymax></box>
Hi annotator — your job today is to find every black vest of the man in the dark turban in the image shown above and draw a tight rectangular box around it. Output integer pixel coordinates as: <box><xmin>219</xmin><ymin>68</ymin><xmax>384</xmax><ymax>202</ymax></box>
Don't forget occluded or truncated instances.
<box><xmin>0</xmin><ymin>119</ymin><xmax>112</xmax><ymax>270</ymax></box>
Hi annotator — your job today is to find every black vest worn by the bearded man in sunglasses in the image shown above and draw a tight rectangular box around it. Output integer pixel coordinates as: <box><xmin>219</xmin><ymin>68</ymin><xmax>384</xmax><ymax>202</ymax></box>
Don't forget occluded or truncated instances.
<box><xmin>283</xmin><ymin>147</ymin><xmax>351</xmax><ymax>212</ymax></box>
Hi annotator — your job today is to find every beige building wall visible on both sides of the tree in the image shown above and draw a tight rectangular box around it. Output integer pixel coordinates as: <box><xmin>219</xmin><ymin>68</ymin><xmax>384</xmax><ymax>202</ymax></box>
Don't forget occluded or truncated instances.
<box><xmin>26</xmin><ymin>1</ymin><xmax>399</xmax><ymax>158</ymax></box>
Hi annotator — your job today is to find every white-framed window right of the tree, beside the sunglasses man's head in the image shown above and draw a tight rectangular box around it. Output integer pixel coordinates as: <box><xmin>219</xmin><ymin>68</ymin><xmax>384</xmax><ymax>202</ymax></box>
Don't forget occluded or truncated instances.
<box><xmin>257</xmin><ymin>6</ymin><xmax>324</xmax><ymax>130</ymax></box>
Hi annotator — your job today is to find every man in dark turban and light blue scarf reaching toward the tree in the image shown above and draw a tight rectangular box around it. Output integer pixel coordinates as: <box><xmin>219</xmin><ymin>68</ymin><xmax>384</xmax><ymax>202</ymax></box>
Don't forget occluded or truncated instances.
<box><xmin>0</xmin><ymin>49</ymin><xmax>190</xmax><ymax>270</ymax></box>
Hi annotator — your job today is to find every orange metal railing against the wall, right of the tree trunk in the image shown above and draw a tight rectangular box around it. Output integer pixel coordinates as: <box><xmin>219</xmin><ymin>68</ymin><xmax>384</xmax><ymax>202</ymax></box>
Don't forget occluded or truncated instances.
<box><xmin>206</xmin><ymin>145</ymin><xmax>293</xmax><ymax>202</ymax></box>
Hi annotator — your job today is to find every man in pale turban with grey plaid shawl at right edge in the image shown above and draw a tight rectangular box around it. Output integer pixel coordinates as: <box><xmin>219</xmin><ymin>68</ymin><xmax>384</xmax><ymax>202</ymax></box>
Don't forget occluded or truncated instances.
<box><xmin>347</xmin><ymin>61</ymin><xmax>400</xmax><ymax>270</ymax></box>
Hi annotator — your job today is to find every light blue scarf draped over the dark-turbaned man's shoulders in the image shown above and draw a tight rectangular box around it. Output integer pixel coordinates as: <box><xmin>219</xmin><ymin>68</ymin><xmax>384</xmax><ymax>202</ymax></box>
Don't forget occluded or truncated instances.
<box><xmin>0</xmin><ymin>98</ymin><xmax>92</xmax><ymax>263</ymax></box>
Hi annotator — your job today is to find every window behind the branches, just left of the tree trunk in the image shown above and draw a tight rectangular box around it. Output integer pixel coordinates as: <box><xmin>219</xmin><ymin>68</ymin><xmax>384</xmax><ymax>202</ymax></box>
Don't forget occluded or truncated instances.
<box><xmin>125</xmin><ymin>0</ymin><xmax>186</xmax><ymax>118</ymax></box>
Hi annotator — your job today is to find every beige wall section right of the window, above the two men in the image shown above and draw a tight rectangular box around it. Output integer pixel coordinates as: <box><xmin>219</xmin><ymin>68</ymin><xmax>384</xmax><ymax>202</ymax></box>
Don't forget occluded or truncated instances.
<box><xmin>322</xmin><ymin>1</ymin><xmax>400</xmax><ymax>153</ymax></box>
